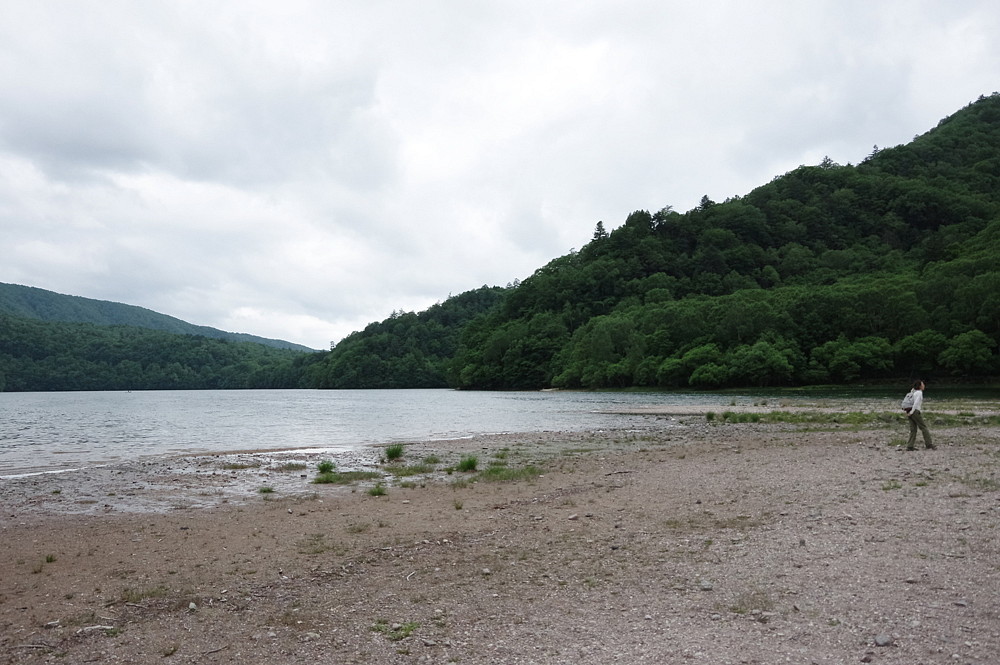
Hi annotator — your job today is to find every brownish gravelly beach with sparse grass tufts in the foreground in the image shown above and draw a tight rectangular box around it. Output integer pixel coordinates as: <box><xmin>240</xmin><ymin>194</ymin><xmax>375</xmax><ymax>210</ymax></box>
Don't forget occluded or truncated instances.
<box><xmin>0</xmin><ymin>409</ymin><xmax>1000</xmax><ymax>664</ymax></box>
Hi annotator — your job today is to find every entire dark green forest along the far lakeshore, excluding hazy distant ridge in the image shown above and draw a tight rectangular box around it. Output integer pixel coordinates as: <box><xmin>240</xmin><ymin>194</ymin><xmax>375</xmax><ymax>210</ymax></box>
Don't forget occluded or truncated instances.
<box><xmin>0</xmin><ymin>93</ymin><xmax>1000</xmax><ymax>390</ymax></box>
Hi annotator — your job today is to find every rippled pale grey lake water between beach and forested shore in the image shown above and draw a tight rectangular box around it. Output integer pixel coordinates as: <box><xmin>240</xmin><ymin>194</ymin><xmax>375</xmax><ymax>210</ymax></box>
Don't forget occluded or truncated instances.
<box><xmin>0</xmin><ymin>390</ymin><xmax>752</xmax><ymax>477</ymax></box>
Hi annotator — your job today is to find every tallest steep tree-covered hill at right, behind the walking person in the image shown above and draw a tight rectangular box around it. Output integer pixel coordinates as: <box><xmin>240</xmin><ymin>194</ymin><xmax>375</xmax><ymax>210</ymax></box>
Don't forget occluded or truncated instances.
<box><xmin>449</xmin><ymin>93</ymin><xmax>1000</xmax><ymax>389</ymax></box>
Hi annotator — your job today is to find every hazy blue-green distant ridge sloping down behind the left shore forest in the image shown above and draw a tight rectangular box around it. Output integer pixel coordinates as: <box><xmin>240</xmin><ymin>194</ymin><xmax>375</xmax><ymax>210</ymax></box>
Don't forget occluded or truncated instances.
<box><xmin>0</xmin><ymin>283</ymin><xmax>315</xmax><ymax>351</ymax></box>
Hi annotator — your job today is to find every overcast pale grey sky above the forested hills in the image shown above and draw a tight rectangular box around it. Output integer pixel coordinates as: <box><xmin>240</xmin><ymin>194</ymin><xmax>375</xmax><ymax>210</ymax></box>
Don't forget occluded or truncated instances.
<box><xmin>0</xmin><ymin>0</ymin><xmax>1000</xmax><ymax>348</ymax></box>
